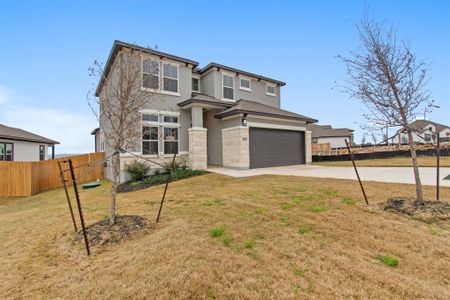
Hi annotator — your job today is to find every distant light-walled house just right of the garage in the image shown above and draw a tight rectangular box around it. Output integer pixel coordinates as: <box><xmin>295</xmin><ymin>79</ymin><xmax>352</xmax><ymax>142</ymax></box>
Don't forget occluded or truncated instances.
<box><xmin>308</xmin><ymin>124</ymin><xmax>354</xmax><ymax>149</ymax></box>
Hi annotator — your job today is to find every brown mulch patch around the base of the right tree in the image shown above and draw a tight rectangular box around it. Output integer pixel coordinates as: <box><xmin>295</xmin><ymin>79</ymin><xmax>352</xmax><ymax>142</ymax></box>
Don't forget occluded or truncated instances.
<box><xmin>381</xmin><ymin>197</ymin><xmax>450</xmax><ymax>223</ymax></box>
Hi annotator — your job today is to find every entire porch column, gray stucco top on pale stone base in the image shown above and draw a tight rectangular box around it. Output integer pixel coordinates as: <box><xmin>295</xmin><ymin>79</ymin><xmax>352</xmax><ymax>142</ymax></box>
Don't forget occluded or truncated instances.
<box><xmin>188</xmin><ymin>106</ymin><xmax>207</xmax><ymax>170</ymax></box>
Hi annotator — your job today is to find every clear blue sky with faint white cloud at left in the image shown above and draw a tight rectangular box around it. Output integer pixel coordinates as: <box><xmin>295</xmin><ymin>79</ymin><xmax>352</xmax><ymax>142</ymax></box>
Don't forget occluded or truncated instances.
<box><xmin>0</xmin><ymin>0</ymin><xmax>450</xmax><ymax>153</ymax></box>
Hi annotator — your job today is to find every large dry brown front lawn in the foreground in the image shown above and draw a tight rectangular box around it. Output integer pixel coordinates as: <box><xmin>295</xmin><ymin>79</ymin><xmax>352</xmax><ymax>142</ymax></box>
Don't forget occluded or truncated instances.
<box><xmin>0</xmin><ymin>174</ymin><xmax>450</xmax><ymax>299</ymax></box>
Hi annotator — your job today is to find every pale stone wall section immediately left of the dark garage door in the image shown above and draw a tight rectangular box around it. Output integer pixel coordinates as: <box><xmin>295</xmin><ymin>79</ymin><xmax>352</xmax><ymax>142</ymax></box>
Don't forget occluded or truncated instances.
<box><xmin>222</xmin><ymin>126</ymin><xmax>250</xmax><ymax>169</ymax></box>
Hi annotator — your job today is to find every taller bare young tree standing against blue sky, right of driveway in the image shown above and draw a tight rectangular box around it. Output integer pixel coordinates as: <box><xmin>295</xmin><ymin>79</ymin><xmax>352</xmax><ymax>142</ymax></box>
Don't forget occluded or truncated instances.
<box><xmin>339</xmin><ymin>17</ymin><xmax>433</xmax><ymax>200</ymax></box>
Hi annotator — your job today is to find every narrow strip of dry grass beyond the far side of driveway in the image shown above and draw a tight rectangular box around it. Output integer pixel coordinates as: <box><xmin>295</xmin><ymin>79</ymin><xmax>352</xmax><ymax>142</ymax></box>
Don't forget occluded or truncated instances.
<box><xmin>314</xmin><ymin>156</ymin><xmax>450</xmax><ymax>167</ymax></box>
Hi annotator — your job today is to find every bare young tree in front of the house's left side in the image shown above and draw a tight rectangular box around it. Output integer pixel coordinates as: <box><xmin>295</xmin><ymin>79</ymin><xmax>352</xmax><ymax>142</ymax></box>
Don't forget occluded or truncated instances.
<box><xmin>88</xmin><ymin>48</ymin><xmax>155</xmax><ymax>225</ymax></box>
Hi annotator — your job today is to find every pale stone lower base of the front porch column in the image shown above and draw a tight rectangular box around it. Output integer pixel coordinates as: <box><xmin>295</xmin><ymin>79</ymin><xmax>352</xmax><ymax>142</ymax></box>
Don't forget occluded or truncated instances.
<box><xmin>188</xmin><ymin>127</ymin><xmax>208</xmax><ymax>170</ymax></box>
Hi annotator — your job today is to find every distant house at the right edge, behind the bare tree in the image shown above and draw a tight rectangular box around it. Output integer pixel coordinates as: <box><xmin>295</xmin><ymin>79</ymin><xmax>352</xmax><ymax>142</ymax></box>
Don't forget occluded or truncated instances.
<box><xmin>393</xmin><ymin>120</ymin><xmax>450</xmax><ymax>144</ymax></box>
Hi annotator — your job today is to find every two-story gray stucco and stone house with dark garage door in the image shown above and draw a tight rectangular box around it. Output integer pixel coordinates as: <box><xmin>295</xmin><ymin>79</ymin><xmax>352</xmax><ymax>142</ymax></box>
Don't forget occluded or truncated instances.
<box><xmin>92</xmin><ymin>41</ymin><xmax>317</xmax><ymax>180</ymax></box>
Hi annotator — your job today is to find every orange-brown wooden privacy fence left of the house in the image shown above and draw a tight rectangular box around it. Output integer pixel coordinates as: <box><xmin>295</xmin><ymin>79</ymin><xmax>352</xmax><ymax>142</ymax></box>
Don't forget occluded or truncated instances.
<box><xmin>0</xmin><ymin>152</ymin><xmax>105</xmax><ymax>197</ymax></box>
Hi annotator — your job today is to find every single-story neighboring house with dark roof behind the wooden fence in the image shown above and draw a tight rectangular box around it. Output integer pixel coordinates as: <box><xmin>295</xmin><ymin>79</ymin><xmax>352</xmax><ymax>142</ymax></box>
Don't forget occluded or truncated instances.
<box><xmin>0</xmin><ymin>124</ymin><xmax>59</xmax><ymax>161</ymax></box>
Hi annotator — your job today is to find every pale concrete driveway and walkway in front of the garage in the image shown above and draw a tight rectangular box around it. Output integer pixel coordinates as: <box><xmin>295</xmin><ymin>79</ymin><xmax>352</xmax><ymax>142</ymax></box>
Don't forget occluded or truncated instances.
<box><xmin>208</xmin><ymin>165</ymin><xmax>450</xmax><ymax>187</ymax></box>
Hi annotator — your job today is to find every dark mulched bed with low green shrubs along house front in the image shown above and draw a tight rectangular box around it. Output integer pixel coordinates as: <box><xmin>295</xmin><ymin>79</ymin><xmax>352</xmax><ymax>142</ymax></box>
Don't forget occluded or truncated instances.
<box><xmin>117</xmin><ymin>169</ymin><xmax>208</xmax><ymax>193</ymax></box>
